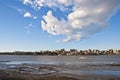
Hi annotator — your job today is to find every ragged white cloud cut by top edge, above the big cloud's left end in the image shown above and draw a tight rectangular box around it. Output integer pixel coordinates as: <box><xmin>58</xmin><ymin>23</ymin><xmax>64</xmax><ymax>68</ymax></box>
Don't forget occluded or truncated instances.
<box><xmin>23</xmin><ymin>0</ymin><xmax>73</xmax><ymax>11</ymax></box>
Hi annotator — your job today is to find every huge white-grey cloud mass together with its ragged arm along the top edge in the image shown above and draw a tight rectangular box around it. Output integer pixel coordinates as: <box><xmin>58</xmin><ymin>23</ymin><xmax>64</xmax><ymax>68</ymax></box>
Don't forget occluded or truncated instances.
<box><xmin>23</xmin><ymin>0</ymin><xmax>120</xmax><ymax>42</ymax></box>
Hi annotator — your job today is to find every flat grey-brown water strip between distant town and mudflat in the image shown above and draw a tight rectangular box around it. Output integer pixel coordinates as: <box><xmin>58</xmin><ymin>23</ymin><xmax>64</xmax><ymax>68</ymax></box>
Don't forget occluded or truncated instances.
<box><xmin>0</xmin><ymin>55</ymin><xmax>120</xmax><ymax>64</ymax></box>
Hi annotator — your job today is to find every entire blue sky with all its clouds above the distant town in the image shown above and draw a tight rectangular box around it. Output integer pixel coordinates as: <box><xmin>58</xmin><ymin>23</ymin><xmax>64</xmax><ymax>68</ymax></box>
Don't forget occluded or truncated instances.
<box><xmin>0</xmin><ymin>0</ymin><xmax>120</xmax><ymax>52</ymax></box>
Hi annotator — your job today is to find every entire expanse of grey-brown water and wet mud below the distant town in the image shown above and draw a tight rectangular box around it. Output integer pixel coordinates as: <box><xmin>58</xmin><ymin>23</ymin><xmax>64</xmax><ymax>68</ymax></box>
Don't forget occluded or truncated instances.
<box><xmin>0</xmin><ymin>55</ymin><xmax>120</xmax><ymax>80</ymax></box>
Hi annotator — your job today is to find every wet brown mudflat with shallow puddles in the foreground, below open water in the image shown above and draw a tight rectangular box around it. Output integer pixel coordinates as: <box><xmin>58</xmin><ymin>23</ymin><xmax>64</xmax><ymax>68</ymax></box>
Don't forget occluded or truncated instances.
<box><xmin>0</xmin><ymin>62</ymin><xmax>120</xmax><ymax>80</ymax></box>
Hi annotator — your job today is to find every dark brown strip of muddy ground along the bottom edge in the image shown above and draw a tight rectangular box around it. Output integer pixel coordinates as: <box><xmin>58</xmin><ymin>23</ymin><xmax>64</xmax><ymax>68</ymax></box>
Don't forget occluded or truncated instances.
<box><xmin>0</xmin><ymin>70</ymin><xmax>120</xmax><ymax>80</ymax></box>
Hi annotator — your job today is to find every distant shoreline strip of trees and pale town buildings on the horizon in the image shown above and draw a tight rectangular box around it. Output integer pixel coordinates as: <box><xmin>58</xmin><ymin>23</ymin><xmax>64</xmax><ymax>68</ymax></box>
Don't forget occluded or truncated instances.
<box><xmin>0</xmin><ymin>49</ymin><xmax>120</xmax><ymax>56</ymax></box>
